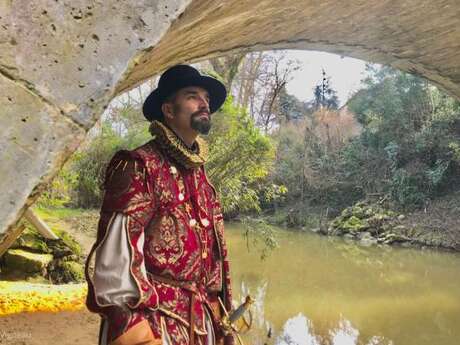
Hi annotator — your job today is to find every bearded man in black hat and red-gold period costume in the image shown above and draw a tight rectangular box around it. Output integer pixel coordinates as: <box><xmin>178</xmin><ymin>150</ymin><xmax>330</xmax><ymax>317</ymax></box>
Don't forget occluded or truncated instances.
<box><xmin>86</xmin><ymin>65</ymin><xmax>233</xmax><ymax>345</ymax></box>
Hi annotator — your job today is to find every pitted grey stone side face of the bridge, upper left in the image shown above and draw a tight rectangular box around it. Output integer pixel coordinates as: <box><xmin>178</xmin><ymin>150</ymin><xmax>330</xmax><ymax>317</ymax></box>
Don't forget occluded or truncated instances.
<box><xmin>0</xmin><ymin>0</ymin><xmax>189</xmax><ymax>241</ymax></box>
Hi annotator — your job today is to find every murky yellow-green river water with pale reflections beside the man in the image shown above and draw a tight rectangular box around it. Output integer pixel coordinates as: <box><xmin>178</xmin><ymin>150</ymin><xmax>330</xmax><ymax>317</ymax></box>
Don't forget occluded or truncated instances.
<box><xmin>226</xmin><ymin>224</ymin><xmax>460</xmax><ymax>345</ymax></box>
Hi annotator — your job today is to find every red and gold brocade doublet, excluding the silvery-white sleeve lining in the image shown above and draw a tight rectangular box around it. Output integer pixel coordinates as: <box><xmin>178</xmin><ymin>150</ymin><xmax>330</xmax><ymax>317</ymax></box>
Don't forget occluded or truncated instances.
<box><xmin>86</xmin><ymin>140</ymin><xmax>231</xmax><ymax>345</ymax></box>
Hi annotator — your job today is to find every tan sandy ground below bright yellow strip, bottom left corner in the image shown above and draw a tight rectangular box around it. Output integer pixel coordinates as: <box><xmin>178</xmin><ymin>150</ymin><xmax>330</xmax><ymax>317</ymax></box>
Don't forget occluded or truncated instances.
<box><xmin>0</xmin><ymin>310</ymin><xmax>100</xmax><ymax>345</ymax></box>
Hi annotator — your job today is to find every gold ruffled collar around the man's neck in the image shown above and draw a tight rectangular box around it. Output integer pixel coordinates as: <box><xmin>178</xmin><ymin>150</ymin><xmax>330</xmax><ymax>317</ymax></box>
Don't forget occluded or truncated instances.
<box><xmin>149</xmin><ymin>120</ymin><xmax>208</xmax><ymax>169</ymax></box>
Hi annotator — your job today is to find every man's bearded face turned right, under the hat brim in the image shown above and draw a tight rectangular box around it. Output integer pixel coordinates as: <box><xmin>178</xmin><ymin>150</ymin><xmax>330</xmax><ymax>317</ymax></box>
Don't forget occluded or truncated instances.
<box><xmin>163</xmin><ymin>86</ymin><xmax>211</xmax><ymax>134</ymax></box>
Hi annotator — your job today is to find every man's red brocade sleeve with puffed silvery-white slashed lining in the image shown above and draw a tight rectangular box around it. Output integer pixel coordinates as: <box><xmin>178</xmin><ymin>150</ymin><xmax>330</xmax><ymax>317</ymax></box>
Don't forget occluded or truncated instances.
<box><xmin>86</xmin><ymin>151</ymin><xmax>158</xmax><ymax>313</ymax></box>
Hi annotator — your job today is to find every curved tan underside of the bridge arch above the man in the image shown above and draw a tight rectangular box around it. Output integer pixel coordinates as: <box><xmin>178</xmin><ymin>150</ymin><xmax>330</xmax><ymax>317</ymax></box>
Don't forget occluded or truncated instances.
<box><xmin>117</xmin><ymin>0</ymin><xmax>460</xmax><ymax>97</ymax></box>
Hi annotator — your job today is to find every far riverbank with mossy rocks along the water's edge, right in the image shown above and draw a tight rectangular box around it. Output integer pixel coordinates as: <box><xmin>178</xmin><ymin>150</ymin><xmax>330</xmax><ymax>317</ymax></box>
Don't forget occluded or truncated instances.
<box><xmin>264</xmin><ymin>192</ymin><xmax>460</xmax><ymax>251</ymax></box>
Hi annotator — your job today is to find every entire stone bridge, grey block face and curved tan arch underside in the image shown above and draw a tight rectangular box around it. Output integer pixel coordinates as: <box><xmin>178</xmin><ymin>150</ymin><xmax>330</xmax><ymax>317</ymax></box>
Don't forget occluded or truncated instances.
<box><xmin>0</xmin><ymin>0</ymin><xmax>460</xmax><ymax>237</ymax></box>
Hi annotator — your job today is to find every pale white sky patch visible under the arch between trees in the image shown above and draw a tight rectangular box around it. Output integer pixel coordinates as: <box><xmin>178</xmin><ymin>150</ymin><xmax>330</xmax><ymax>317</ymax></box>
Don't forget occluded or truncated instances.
<box><xmin>286</xmin><ymin>50</ymin><xmax>366</xmax><ymax>106</ymax></box>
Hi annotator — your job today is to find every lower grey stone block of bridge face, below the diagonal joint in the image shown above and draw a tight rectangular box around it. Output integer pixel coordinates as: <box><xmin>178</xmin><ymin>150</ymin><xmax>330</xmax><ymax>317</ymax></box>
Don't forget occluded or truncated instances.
<box><xmin>0</xmin><ymin>75</ymin><xmax>85</xmax><ymax>243</ymax></box>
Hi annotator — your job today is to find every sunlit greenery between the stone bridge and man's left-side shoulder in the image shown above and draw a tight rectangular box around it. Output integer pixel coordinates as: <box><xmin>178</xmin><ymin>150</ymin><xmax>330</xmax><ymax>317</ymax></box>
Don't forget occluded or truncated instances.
<box><xmin>39</xmin><ymin>102</ymin><xmax>150</xmax><ymax>208</ymax></box>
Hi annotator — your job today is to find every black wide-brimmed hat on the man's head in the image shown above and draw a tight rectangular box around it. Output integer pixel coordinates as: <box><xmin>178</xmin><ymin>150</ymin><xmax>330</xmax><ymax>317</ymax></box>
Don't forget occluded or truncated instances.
<box><xmin>142</xmin><ymin>65</ymin><xmax>227</xmax><ymax>121</ymax></box>
